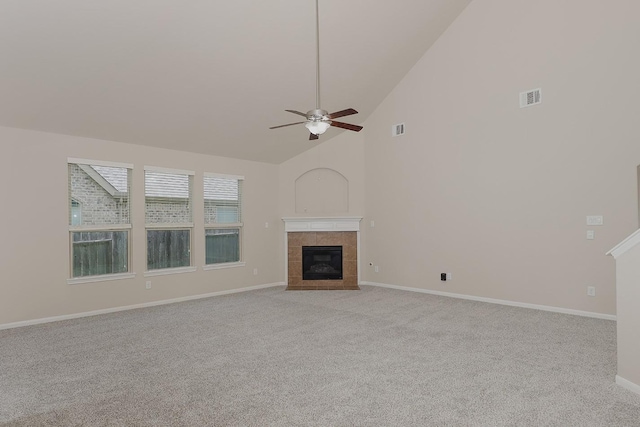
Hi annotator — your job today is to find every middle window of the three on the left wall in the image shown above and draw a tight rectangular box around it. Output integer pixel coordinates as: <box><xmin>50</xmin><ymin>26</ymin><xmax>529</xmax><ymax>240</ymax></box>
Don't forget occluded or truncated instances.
<box><xmin>144</xmin><ymin>167</ymin><xmax>193</xmax><ymax>271</ymax></box>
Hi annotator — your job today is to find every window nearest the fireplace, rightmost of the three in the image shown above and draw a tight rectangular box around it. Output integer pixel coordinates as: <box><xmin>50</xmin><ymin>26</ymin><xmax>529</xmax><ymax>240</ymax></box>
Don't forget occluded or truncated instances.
<box><xmin>204</xmin><ymin>174</ymin><xmax>244</xmax><ymax>265</ymax></box>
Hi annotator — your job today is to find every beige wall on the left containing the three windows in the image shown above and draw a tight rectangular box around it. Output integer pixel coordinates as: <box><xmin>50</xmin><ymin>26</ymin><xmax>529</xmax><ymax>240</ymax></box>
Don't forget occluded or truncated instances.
<box><xmin>0</xmin><ymin>128</ymin><xmax>283</xmax><ymax>325</ymax></box>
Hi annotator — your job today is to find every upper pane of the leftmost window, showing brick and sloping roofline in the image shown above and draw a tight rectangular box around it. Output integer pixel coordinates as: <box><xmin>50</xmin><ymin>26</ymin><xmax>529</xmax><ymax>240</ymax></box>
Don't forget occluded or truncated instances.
<box><xmin>69</xmin><ymin>163</ymin><xmax>131</xmax><ymax>226</ymax></box>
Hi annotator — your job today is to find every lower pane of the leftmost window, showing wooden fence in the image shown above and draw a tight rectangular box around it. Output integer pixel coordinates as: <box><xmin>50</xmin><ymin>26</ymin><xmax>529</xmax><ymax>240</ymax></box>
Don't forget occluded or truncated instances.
<box><xmin>71</xmin><ymin>231</ymin><xmax>129</xmax><ymax>277</ymax></box>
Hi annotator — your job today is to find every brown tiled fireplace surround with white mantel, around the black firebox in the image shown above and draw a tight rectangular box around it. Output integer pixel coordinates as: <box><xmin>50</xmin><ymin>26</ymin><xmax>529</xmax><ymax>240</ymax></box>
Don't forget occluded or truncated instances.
<box><xmin>283</xmin><ymin>217</ymin><xmax>361</xmax><ymax>291</ymax></box>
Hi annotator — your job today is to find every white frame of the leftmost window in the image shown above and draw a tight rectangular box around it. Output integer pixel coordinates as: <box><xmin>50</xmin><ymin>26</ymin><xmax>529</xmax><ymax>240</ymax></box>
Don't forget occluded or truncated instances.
<box><xmin>66</xmin><ymin>157</ymin><xmax>136</xmax><ymax>285</ymax></box>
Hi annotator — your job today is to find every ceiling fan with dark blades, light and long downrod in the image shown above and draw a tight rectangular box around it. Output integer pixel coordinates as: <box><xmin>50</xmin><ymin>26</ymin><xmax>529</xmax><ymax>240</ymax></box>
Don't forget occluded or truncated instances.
<box><xmin>269</xmin><ymin>0</ymin><xmax>362</xmax><ymax>140</ymax></box>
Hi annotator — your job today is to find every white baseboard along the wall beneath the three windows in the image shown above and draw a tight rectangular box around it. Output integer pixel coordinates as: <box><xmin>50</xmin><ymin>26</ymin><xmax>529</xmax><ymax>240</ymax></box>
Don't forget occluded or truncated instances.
<box><xmin>0</xmin><ymin>282</ymin><xmax>284</xmax><ymax>330</ymax></box>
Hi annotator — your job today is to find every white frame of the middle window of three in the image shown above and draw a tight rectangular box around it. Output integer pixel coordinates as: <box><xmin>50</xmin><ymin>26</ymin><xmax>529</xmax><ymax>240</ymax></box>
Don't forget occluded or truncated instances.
<box><xmin>143</xmin><ymin>166</ymin><xmax>197</xmax><ymax>277</ymax></box>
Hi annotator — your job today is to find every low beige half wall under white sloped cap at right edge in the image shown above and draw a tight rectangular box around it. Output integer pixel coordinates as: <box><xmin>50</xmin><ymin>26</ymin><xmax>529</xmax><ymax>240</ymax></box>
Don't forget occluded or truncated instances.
<box><xmin>616</xmin><ymin>241</ymin><xmax>640</xmax><ymax>388</ymax></box>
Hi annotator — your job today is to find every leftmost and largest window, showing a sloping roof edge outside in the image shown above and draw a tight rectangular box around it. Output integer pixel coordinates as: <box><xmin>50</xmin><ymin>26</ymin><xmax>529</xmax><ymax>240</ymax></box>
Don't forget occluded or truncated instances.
<box><xmin>68</xmin><ymin>159</ymin><xmax>132</xmax><ymax>283</ymax></box>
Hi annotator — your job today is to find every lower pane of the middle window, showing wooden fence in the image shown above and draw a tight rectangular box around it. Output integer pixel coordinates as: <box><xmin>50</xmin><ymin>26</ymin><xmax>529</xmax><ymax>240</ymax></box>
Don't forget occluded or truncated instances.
<box><xmin>147</xmin><ymin>230</ymin><xmax>191</xmax><ymax>270</ymax></box>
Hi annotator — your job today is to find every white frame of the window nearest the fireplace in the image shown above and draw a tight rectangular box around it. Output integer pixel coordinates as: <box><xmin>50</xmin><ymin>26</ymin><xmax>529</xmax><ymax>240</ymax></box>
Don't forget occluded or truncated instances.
<box><xmin>202</xmin><ymin>172</ymin><xmax>246</xmax><ymax>270</ymax></box>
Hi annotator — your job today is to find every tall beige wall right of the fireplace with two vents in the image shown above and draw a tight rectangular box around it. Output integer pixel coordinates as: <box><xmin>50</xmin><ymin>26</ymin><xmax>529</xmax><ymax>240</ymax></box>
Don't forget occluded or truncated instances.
<box><xmin>363</xmin><ymin>0</ymin><xmax>640</xmax><ymax>314</ymax></box>
